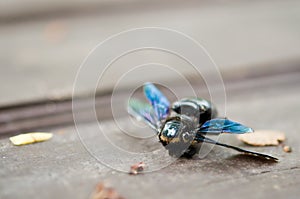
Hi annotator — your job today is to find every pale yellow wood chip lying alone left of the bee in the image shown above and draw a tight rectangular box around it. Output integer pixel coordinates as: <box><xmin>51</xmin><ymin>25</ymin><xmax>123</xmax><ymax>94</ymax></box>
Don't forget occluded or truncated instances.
<box><xmin>9</xmin><ymin>132</ymin><xmax>53</xmax><ymax>146</ymax></box>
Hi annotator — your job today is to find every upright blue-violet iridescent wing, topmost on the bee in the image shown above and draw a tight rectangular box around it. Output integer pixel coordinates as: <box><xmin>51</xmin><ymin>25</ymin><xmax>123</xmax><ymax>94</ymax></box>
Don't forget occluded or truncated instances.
<box><xmin>144</xmin><ymin>83</ymin><xmax>170</xmax><ymax>121</ymax></box>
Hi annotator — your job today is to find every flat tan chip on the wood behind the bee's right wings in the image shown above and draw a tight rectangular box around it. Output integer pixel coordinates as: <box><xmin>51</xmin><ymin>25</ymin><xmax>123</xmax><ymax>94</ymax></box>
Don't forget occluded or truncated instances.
<box><xmin>237</xmin><ymin>130</ymin><xmax>285</xmax><ymax>146</ymax></box>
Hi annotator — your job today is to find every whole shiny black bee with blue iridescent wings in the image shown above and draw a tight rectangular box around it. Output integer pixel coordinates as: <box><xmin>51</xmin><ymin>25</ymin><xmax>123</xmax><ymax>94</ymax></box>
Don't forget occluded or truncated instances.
<box><xmin>128</xmin><ymin>83</ymin><xmax>278</xmax><ymax>161</ymax></box>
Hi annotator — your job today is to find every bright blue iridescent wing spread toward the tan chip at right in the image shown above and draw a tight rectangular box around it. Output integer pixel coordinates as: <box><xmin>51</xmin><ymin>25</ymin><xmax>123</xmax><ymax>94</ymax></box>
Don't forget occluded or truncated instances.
<box><xmin>197</xmin><ymin>118</ymin><xmax>253</xmax><ymax>134</ymax></box>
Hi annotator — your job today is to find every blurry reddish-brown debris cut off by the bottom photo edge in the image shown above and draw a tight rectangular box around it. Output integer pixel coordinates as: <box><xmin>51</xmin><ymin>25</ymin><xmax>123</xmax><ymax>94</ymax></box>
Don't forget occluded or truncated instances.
<box><xmin>90</xmin><ymin>183</ymin><xmax>124</xmax><ymax>199</ymax></box>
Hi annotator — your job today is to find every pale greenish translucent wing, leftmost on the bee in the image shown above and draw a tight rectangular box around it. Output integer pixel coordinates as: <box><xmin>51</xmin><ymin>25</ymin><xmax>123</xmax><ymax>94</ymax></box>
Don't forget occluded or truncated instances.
<box><xmin>127</xmin><ymin>99</ymin><xmax>158</xmax><ymax>131</ymax></box>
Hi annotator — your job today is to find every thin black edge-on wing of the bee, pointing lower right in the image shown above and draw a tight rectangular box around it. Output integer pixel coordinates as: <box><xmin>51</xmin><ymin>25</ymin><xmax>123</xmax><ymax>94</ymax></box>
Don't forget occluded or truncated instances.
<box><xmin>195</xmin><ymin>134</ymin><xmax>278</xmax><ymax>161</ymax></box>
